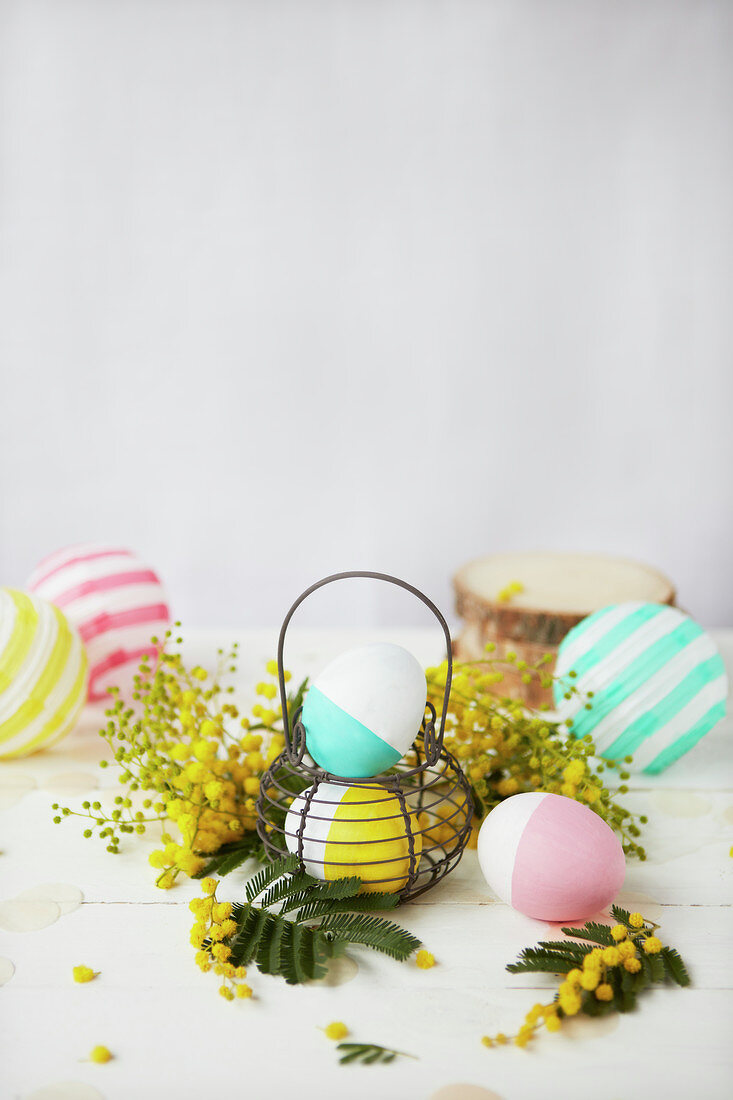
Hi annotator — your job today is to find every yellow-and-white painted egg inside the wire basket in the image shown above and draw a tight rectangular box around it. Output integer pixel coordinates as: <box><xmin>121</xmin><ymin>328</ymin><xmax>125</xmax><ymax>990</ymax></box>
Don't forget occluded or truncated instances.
<box><xmin>285</xmin><ymin>783</ymin><xmax>423</xmax><ymax>893</ymax></box>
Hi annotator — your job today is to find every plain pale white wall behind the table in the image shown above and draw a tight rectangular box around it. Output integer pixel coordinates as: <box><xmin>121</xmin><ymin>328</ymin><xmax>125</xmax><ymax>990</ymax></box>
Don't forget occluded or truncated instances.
<box><xmin>0</xmin><ymin>0</ymin><xmax>733</xmax><ymax>625</ymax></box>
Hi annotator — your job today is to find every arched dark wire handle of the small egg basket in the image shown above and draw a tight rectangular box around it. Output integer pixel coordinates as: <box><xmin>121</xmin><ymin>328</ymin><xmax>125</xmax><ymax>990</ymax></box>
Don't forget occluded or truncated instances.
<box><xmin>277</xmin><ymin>570</ymin><xmax>453</xmax><ymax>765</ymax></box>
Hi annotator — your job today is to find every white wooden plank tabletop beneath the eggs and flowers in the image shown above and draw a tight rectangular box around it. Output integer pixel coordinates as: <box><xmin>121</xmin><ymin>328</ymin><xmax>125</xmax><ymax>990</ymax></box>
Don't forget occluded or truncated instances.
<box><xmin>0</xmin><ymin>630</ymin><xmax>733</xmax><ymax>1100</ymax></box>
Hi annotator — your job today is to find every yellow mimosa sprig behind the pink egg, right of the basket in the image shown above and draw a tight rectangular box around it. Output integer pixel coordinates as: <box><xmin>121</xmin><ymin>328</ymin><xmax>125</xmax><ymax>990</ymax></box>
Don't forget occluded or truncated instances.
<box><xmin>427</xmin><ymin>644</ymin><xmax>647</xmax><ymax>859</ymax></box>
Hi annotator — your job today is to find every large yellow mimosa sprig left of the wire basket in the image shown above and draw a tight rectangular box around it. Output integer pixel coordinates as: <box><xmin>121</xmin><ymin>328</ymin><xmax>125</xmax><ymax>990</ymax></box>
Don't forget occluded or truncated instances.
<box><xmin>54</xmin><ymin>624</ymin><xmax>306</xmax><ymax>889</ymax></box>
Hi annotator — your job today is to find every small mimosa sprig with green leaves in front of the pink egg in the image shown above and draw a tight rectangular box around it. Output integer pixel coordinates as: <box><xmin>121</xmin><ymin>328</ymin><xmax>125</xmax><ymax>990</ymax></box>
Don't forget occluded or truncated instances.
<box><xmin>482</xmin><ymin>905</ymin><xmax>690</xmax><ymax>1046</ymax></box>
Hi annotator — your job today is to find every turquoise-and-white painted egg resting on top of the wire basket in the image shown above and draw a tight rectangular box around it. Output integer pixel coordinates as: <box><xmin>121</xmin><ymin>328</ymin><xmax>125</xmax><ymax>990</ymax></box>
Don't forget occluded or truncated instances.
<box><xmin>300</xmin><ymin>642</ymin><xmax>427</xmax><ymax>779</ymax></box>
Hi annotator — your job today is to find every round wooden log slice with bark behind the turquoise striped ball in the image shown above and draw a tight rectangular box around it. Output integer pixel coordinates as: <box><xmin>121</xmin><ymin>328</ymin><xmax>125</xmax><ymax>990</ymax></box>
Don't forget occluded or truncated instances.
<box><xmin>453</xmin><ymin>552</ymin><xmax>676</xmax><ymax>706</ymax></box>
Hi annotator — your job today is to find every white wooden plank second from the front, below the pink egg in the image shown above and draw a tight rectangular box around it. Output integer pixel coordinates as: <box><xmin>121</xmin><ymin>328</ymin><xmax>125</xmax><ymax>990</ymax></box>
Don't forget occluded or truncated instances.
<box><xmin>0</xmin><ymin>887</ymin><xmax>733</xmax><ymax>997</ymax></box>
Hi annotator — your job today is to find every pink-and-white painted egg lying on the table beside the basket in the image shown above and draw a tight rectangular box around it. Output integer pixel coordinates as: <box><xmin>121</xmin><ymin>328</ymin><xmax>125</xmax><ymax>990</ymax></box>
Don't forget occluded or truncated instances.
<box><xmin>478</xmin><ymin>791</ymin><xmax>626</xmax><ymax>921</ymax></box>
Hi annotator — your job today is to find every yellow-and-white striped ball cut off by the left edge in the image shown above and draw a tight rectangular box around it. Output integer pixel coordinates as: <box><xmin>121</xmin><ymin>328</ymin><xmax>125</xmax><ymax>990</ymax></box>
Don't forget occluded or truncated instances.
<box><xmin>0</xmin><ymin>589</ymin><xmax>87</xmax><ymax>758</ymax></box>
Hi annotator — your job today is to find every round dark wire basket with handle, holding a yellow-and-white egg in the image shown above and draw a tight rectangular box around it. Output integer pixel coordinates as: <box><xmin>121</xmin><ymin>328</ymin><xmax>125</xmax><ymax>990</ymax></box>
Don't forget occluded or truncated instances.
<box><xmin>256</xmin><ymin>571</ymin><xmax>473</xmax><ymax>901</ymax></box>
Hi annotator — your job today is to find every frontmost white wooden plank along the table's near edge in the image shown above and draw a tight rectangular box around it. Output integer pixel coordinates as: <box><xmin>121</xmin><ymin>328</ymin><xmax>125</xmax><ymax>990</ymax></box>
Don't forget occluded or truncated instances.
<box><xmin>3</xmin><ymin>975</ymin><xmax>732</xmax><ymax>1100</ymax></box>
